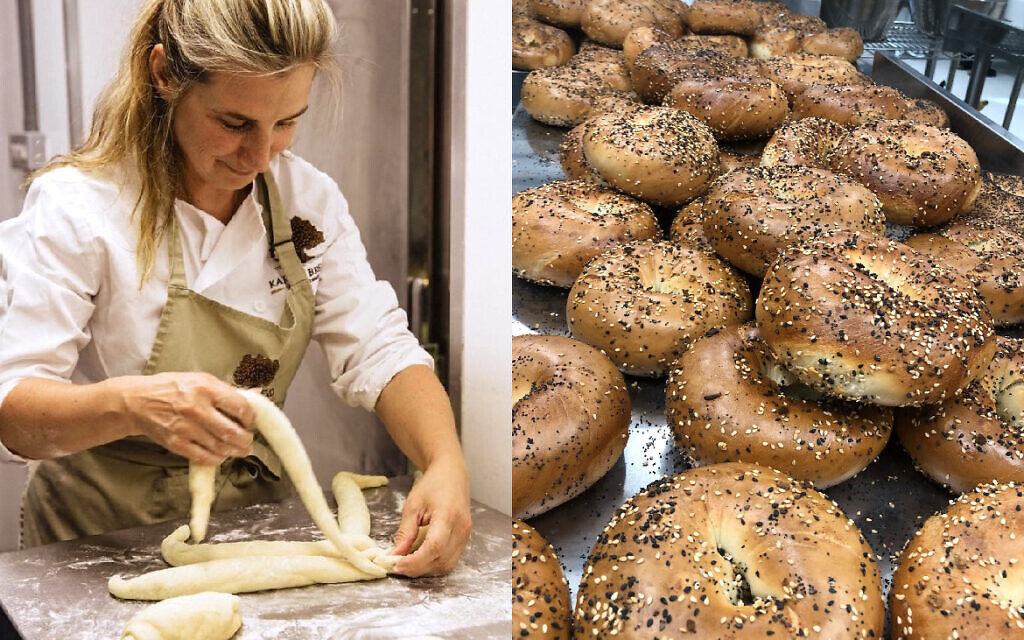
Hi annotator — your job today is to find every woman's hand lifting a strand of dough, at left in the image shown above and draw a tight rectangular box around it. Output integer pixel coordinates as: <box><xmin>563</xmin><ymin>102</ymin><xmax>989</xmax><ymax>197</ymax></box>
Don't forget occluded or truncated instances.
<box><xmin>112</xmin><ymin>372</ymin><xmax>255</xmax><ymax>465</ymax></box>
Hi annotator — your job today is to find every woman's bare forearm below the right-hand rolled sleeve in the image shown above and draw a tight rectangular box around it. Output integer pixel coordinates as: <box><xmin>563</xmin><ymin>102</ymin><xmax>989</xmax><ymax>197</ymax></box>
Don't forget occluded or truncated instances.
<box><xmin>376</xmin><ymin>365</ymin><xmax>465</xmax><ymax>469</ymax></box>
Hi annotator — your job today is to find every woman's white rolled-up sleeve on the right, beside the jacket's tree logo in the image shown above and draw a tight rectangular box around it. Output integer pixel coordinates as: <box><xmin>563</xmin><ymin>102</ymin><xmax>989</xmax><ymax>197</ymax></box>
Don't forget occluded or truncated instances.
<box><xmin>313</xmin><ymin>189</ymin><xmax>433</xmax><ymax>412</ymax></box>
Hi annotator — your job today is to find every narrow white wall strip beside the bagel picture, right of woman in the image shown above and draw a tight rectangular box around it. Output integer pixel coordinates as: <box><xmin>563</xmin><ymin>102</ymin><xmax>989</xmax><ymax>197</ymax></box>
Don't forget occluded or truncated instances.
<box><xmin>447</xmin><ymin>0</ymin><xmax>512</xmax><ymax>513</ymax></box>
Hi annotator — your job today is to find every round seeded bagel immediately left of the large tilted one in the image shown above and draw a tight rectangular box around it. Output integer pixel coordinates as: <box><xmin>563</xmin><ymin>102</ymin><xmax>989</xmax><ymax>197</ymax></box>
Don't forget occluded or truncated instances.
<box><xmin>565</xmin><ymin>241</ymin><xmax>752</xmax><ymax>377</ymax></box>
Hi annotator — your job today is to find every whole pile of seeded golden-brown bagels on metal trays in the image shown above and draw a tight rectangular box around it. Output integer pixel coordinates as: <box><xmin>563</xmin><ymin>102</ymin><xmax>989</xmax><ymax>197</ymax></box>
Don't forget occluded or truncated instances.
<box><xmin>512</xmin><ymin>0</ymin><xmax>1024</xmax><ymax>638</ymax></box>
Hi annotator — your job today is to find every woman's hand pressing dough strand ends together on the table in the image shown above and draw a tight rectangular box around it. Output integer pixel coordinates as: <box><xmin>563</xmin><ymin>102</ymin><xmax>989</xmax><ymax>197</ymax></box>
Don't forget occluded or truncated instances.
<box><xmin>392</xmin><ymin>456</ymin><xmax>471</xmax><ymax>578</ymax></box>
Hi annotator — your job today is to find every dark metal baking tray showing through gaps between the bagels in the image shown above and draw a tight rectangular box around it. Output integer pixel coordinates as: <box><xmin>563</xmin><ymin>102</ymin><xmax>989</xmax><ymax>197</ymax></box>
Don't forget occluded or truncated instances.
<box><xmin>512</xmin><ymin>53</ymin><xmax>1024</xmax><ymax>626</ymax></box>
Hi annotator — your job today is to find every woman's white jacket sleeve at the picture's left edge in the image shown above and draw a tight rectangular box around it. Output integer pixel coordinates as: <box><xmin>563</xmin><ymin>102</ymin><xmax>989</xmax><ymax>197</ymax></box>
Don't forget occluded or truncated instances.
<box><xmin>0</xmin><ymin>181</ymin><xmax>101</xmax><ymax>462</ymax></box>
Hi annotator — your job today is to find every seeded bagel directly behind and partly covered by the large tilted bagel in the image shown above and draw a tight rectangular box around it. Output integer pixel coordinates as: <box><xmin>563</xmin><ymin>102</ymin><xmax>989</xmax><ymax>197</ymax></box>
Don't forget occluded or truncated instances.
<box><xmin>702</xmin><ymin>165</ymin><xmax>886</xmax><ymax>278</ymax></box>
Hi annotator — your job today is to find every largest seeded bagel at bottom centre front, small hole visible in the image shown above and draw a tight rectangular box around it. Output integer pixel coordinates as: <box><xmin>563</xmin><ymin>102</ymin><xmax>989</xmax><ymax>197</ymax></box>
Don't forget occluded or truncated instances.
<box><xmin>572</xmin><ymin>464</ymin><xmax>885</xmax><ymax>640</ymax></box>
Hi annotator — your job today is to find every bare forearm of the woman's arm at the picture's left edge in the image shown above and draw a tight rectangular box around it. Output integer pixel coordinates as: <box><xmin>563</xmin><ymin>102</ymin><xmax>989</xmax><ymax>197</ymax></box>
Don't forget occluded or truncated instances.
<box><xmin>0</xmin><ymin>378</ymin><xmax>130</xmax><ymax>460</ymax></box>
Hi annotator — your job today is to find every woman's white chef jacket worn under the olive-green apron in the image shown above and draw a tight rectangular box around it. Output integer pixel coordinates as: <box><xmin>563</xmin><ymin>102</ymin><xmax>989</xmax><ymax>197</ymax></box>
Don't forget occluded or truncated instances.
<box><xmin>0</xmin><ymin>152</ymin><xmax>433</xmax><ymax>462</ymax></box>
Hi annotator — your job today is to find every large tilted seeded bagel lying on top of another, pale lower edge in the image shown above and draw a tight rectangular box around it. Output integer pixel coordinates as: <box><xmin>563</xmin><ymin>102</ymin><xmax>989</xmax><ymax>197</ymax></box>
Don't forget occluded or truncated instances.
<box><xmin>756</xmin><ymin>231</ymin><xmax>995</xmax><ymax>407</ymax></box>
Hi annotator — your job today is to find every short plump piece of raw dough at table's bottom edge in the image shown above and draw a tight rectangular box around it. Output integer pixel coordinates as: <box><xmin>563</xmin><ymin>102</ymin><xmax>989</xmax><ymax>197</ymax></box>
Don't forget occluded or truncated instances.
<box><xmin>121</xmin><ymin>593</ymin><xmax>242</xmax><ymax>640</ymax></box>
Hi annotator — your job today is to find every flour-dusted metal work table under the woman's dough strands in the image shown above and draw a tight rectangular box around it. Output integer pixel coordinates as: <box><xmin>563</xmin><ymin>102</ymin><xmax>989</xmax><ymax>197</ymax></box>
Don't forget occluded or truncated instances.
<box><xmin>0</xmin><ymin>476</ymin><xmax>512</xmax><ymax>640</ymax></box>
